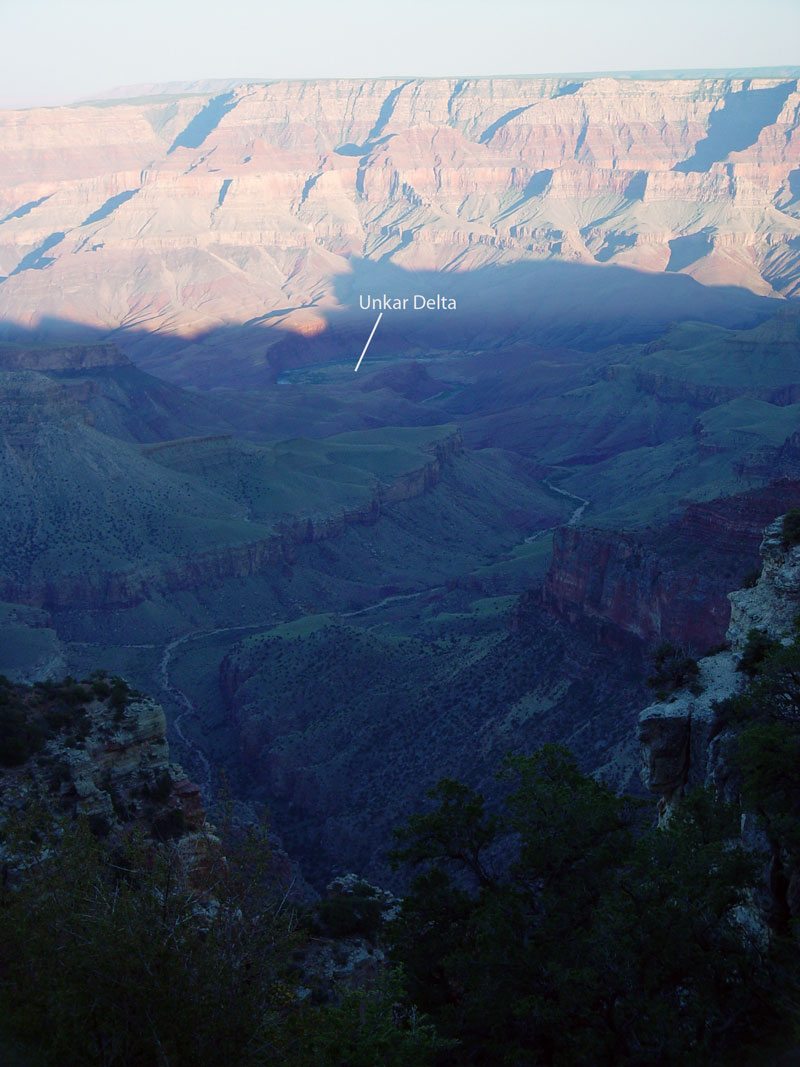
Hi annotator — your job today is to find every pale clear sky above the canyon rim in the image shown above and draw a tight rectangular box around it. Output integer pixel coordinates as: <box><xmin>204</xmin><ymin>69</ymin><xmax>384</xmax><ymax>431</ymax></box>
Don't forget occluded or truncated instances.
<box><xmin>0</xmin><ymin>0</ymin><xmax>800</xmax><ymax>108</ymax></box>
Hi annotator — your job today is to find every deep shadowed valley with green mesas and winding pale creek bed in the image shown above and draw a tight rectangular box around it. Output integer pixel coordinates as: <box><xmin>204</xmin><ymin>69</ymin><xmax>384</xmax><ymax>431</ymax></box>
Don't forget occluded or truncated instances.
<box><xmin>0</xmin><ymin>292</ymin><xmax>800</xmax><ymax>886</ymax></box>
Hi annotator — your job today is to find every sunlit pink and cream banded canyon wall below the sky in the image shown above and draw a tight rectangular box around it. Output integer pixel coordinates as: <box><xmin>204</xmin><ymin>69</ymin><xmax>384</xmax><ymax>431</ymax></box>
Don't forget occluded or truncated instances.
<box><xmin>0</xmin><ymin>77</ymin><xmax>800</xmax><ymax>379</ymax></box>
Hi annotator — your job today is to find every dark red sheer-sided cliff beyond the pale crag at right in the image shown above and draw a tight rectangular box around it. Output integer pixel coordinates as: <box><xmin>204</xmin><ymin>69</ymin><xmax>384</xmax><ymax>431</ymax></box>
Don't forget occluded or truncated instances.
<box><xmin>542</xmin><ymin>480</ymin><xmax>800</xmax><ymax>655</ymax></box>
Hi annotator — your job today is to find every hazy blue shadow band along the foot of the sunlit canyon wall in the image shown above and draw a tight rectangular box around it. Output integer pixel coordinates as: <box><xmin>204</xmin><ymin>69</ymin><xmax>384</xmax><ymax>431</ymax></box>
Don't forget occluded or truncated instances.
<box><xmin>0</xmin><ymin>256</ymin><xmax>789</xmax><ymax>389</ymax></box>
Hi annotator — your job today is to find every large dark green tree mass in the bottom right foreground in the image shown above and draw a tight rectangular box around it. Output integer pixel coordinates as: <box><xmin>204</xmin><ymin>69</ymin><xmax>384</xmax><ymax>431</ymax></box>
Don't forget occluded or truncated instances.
<box><xmin>393</xmin><ymin>747</ymin><xmax>796</xmax><ymax>1067</ymax></box>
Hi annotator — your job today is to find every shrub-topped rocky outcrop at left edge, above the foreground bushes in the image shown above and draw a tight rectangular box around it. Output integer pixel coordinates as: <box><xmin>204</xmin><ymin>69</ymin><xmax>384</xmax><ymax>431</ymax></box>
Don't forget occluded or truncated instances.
<box><xmin>0</xmin><ymin>674</ymin><xmax>212</xmax><ymax>876</ymax></box>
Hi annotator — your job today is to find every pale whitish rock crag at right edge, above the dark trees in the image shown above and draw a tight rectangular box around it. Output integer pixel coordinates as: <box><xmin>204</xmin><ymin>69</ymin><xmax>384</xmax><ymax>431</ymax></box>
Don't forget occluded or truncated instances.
<box><xmin>639</xmin><ymin>520</ymin><xmax>800</xmax><ymax>813</ymax></box>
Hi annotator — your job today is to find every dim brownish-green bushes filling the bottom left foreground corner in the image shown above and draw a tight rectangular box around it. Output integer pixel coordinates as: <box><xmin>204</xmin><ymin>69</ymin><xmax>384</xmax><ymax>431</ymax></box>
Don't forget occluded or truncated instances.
<box><xmin>0</xmin><ymin>810</ymin><xmax>443</xmax><ymax>1067</ymax></box>
